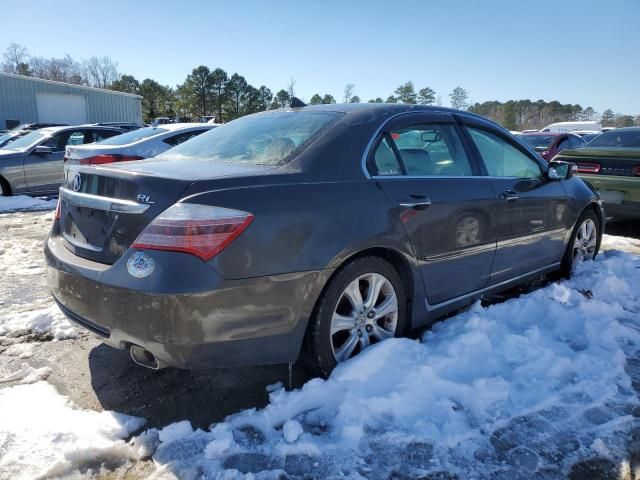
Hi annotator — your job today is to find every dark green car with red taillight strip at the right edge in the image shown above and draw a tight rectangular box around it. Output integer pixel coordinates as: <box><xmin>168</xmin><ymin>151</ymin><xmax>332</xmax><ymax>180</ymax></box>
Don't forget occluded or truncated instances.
<box><xmin>554</xmin><ymin>127</ymin><xmax>640</xmax><ymax>219</ymax></box>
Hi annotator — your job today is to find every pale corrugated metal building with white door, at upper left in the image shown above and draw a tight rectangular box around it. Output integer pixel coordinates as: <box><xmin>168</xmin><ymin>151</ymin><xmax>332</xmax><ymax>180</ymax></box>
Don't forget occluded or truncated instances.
<box><xmin>0</xmin><ymin>73</ymin><xmax>142</xmax><ymax>129</ymax></box>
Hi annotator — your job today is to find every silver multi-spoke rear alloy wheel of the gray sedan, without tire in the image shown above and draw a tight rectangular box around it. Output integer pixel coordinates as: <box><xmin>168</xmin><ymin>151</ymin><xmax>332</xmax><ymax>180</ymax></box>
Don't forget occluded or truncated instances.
<box><xmin>330</xmin><ymin>273</ymin><xmax>398</xmax><ymax>363</ymax></box>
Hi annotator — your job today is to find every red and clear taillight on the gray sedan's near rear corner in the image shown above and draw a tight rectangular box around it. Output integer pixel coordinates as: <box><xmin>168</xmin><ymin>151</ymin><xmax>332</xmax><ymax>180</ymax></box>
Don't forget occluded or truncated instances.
<box><xmin>132</xmin><ymin>203</ymin><xmax>253</xmax><ymax>260</ymax></box>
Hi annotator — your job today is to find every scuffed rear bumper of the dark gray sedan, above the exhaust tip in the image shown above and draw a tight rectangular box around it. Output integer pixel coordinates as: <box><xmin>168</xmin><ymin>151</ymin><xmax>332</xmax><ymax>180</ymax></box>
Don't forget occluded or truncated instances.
<box><xmin>45</xmin><ymin>237</ymin><xmax>333</xmax><ymax>368</ymax></box>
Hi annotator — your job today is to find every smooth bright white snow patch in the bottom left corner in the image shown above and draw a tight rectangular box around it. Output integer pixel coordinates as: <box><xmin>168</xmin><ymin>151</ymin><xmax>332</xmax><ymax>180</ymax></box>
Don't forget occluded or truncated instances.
<box><xmin>0</xmin><ymin>382</ymin><xmax>144</xmax><ymax>479</ymax></box>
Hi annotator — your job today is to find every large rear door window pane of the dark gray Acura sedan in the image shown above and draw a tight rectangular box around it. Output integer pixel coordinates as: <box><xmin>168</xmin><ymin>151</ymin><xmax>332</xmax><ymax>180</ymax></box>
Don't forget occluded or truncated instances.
<box><xmin>391</xmin><ymin>124</ymin><xmax>473</xmax><ymax>177</ymax></box>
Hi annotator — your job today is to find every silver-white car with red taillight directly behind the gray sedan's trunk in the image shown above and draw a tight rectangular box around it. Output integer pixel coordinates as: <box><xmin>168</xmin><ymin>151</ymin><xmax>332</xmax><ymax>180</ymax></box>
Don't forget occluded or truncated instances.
<box><xmin>64</xmin><ymin>123</ymin><xmax>216</xmax><ymax>165</ymax></box>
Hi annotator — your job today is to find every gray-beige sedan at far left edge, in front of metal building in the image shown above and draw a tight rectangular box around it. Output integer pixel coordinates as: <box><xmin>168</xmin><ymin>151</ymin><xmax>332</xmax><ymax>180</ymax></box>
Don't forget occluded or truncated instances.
<box><xmin>0</xmin><ymin>125</ymin><xmax>122</xmax><ymax>195</ymax></box>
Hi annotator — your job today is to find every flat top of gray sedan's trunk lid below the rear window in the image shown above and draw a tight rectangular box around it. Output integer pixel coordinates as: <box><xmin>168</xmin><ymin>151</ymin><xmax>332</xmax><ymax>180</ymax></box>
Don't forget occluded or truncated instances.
<box><xmin>95</xmin><ymin>158</ymin><xmax>280</xmax><ymax>181</ymax></box>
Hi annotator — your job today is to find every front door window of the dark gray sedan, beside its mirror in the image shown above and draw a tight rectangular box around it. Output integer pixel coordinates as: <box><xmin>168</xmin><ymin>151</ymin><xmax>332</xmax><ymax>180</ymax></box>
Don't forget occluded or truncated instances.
<box><xmin>467</xmin><ymin>127</ymin><xmax>542</xmax><ymax>178</ymax></box>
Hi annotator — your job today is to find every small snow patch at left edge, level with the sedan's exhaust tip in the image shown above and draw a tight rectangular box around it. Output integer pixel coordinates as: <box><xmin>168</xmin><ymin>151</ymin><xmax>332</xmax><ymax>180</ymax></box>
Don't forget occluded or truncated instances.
<box><xmin>0</xmin><ymin>305</ymin><xmax>79</xmax><ymax>340</ymax></box>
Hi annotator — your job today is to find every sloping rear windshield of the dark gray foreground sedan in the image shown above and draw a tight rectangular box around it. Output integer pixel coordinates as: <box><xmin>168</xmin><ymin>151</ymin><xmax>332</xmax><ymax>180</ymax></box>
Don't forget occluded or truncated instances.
<box><xmin>156</xmin><ymin>111</ymin><xmax>341</xmax><ymax>166</ymax></box>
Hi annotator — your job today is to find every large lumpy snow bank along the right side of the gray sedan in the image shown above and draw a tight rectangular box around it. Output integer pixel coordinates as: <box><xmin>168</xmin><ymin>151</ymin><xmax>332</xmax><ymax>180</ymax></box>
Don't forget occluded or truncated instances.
<box><xmin>141</xmin><ymin>250</ymin><xmax>640</xmax><ymax>478</ymax></box>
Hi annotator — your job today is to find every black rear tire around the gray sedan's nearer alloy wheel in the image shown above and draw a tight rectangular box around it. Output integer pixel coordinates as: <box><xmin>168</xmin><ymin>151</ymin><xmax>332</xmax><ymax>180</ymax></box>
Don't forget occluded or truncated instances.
<box><xmin>305</xmin><ymin>257</ymin><xmax>407</xmax><ymax>377</ymax></box>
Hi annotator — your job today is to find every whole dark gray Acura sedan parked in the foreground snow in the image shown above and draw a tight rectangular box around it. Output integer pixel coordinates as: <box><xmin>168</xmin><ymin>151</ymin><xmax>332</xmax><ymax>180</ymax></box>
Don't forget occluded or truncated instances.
<box><xmin>45</xmin><ymin>104</ymin><xmax>603</xmax><ymax>375</ymax></box>
